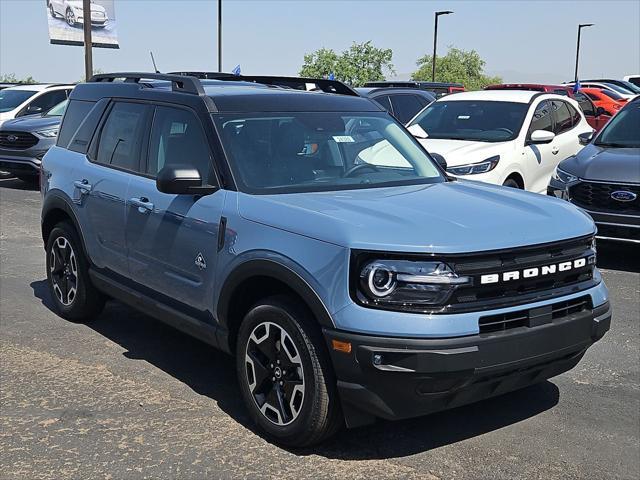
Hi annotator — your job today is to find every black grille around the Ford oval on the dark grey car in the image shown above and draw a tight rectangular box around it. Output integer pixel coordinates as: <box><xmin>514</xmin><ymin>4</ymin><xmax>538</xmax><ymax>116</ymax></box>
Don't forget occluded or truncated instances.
<box><xmin>569</xmin><ymin>182</ymin><xmax>640</xmax><ymax>215</ymax></box>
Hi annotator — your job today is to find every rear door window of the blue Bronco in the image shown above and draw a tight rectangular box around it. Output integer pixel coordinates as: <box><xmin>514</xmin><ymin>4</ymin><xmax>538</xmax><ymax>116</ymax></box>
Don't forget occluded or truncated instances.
<box><xmin>96</xmin><ymin>102</ymin><xmax>149</xmax><ymax>171</ymax></box>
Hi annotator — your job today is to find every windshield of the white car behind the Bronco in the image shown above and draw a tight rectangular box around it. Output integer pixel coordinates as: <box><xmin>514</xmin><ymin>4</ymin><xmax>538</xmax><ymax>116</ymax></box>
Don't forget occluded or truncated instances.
<box><xmin>411</xmin><ymin>100</ymin><xmax>529</xmax><ymax>142</ymax></box>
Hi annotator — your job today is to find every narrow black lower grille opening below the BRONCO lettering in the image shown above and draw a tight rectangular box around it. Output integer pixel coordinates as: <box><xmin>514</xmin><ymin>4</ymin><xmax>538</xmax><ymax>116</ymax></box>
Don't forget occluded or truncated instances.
<box><xmin>478</xmin><ymin>295</ymin><xmax>591</xmax><ymax>333</ymax></box>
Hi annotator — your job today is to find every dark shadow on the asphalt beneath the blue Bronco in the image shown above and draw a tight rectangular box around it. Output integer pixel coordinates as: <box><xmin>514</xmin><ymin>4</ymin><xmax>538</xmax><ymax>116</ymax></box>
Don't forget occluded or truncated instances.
<box><xmin>31</xmin><ymin>280</ymin><xmax>559</xmax><ymax>460</ymax></box>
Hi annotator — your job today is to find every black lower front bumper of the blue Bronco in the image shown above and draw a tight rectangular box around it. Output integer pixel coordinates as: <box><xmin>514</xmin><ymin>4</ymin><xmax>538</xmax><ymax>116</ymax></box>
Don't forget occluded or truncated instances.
<box><xmin>324</xmin><ymin>301</ymin><xmax>611</xmax><ymax>427</ymax></box>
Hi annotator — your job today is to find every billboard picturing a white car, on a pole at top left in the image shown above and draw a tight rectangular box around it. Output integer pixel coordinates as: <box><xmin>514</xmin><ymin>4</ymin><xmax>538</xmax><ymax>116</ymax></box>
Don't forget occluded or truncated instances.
<box><xmin>46</xmin><ymin>0</ymin><xmax>120</xmax><ymax>48</ymax></box>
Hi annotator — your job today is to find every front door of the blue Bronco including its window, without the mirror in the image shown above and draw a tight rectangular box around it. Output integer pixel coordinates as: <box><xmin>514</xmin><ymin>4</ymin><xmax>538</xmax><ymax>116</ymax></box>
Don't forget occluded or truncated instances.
<box><xmin>125</xmin><ymin>106</ymin><xmax>225</xmax><ymax>317</ymax></box>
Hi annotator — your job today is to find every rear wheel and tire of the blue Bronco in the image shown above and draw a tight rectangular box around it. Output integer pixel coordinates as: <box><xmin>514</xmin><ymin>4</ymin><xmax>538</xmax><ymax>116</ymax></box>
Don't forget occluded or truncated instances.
<box><xmin>46</xmin><ymin>222</ymin><xmax>105</xmax><ymax>322</ymax></box>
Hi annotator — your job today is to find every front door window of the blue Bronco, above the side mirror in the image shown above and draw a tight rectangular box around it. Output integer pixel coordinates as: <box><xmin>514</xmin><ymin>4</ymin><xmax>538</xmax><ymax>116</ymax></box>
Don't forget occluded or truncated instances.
<box><xmin>146</xmin><ymin>107</ymin><xmax>212</xmax><ymax>183</ymax></box>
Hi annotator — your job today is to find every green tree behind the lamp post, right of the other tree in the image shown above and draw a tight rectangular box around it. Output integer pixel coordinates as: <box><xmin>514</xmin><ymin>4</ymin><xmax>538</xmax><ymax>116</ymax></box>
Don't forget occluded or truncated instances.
<box><xmin>411</xmin><ymin>46</ymin><xmax>502</xmax><ymax>90</ymax></box>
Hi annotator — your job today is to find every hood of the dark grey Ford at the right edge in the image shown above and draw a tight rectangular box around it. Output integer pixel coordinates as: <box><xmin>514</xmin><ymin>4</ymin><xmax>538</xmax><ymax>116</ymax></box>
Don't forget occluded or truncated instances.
<box><xmin>559</xmin><ymin>144</ymin><xmax>640</xmax><ymax>183</ymax></box>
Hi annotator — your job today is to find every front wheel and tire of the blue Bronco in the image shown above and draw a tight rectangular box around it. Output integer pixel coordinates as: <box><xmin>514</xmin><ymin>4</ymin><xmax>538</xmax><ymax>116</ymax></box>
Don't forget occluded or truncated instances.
<box><xmin>236</xmin><ymin>296</ymin><xmax>343</xmax><ymax>447</ymax></box>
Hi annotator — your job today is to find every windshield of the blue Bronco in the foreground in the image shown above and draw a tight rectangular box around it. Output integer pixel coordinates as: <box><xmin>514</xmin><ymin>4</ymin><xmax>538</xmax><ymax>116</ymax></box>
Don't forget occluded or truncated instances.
<box><xmin>213</xmin><ymin>112</ymin><xmax>444</xmax><ymax>194</ymax></box>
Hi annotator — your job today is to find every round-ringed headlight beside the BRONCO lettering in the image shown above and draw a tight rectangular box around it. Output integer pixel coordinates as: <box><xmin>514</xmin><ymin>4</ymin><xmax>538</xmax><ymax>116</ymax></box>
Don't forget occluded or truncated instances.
<box><xmin>357</xmin><ymin>260</ymin><xmax>471</xmax><ymax>308</ymax></box>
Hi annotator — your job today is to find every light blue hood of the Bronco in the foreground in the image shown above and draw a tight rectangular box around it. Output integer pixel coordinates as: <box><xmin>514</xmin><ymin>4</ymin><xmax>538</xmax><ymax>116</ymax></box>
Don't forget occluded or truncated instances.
<box><xmin>238</xmin><ymin>181</ymin><xmax>595</xmax><ymax>253</ymax></box>
